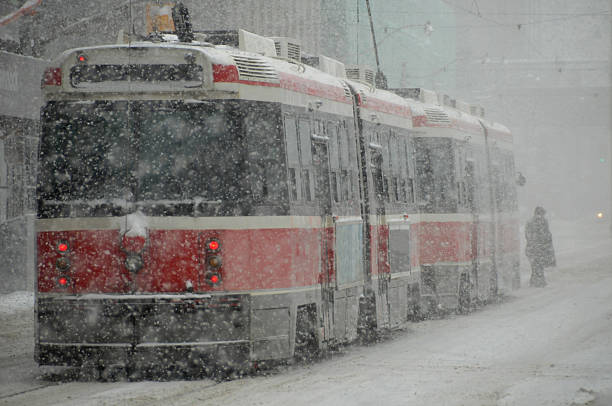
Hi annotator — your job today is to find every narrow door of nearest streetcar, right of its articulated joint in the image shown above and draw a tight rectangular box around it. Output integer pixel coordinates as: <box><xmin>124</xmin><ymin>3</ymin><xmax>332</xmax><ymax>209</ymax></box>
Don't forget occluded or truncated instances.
<box><xmin>371</xmin><ymin>149</ymin><xmax>391</xmax><ymax>329</ymax></box>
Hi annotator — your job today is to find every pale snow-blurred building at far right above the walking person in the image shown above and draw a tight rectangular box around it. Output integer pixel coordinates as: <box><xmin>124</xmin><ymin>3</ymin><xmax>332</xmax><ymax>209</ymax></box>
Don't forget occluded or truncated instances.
<box><xmin>449</xmin><ymin>0</ymin><xmax>612</xmax><ymax>221</ymax></box>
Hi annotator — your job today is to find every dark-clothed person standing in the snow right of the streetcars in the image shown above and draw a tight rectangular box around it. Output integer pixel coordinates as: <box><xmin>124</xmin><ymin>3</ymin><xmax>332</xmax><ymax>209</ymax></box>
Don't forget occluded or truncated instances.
<box><xmin>525</xmin><ymin>206</ymin><xmax>557</xmax><ymax>288</ymax></box>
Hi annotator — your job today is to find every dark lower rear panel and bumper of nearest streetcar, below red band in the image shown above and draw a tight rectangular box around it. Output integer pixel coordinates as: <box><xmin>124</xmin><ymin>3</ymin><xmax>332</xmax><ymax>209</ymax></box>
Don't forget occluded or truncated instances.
<box><xmin>35</xmin><ymin>294</ymin><xmax>251</xmax><ymax>366</ymax></box>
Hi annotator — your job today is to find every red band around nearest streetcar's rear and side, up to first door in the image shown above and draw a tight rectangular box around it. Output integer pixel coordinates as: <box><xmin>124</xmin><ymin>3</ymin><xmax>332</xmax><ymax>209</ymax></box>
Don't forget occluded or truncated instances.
<box><xmin>37</xmin><ymin>229</ymin><xmax>324</xmax><ymax>293</ymax></box>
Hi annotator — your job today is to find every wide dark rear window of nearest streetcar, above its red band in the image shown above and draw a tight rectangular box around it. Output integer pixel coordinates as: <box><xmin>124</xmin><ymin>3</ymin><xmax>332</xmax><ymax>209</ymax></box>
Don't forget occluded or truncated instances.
<box><xmin>38</xmin><ymin>101</ymin><xmax>244</xmax><ymax>215</ymax></box>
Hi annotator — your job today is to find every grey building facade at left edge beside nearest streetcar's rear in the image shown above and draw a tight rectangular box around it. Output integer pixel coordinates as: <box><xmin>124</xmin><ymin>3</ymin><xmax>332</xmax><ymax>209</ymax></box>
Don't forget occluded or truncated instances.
<box><xmin>0</xmin><ymin>51</ymin><xmax>44</xmax><ymax>292</ymax></box>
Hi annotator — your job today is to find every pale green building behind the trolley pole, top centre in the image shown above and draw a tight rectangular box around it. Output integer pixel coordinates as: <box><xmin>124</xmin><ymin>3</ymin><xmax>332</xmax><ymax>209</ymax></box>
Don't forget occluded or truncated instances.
<box><xmin>321</xmin><ymin>0</ymin><xmax>457</xmax><ymax>92</ymax></box>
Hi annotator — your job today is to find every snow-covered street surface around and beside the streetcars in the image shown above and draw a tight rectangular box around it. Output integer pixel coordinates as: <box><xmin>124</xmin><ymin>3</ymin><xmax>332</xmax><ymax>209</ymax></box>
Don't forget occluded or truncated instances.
<box><xmin>0</xmin><ymin>222</ymin><xmax>612</xmax><ymax>406</ymax></box>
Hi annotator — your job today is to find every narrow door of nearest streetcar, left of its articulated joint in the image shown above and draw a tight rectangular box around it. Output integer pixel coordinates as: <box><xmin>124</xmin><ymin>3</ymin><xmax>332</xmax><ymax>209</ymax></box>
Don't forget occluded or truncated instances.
<box><xmin>312</xmin><ymin>134</ymin><xmax>334</xmax><ymax>340</ymax></box>
